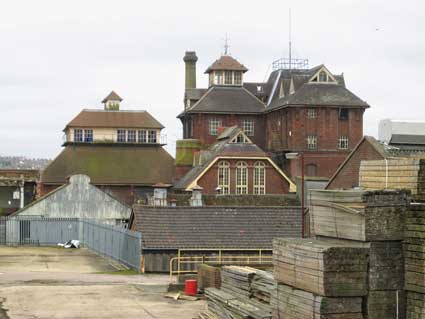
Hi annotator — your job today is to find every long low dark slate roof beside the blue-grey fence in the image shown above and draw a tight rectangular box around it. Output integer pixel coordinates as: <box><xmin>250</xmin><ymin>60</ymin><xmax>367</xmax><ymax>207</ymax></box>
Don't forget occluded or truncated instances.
<box><xmin>130</xmin><ymin>205</ymin><xmax>301</xmax><ymax>250</ymax></box>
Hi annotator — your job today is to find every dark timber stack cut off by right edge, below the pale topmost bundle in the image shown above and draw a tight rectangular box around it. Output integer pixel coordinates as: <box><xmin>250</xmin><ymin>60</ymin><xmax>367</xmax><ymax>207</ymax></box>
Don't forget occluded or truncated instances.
<box><xmin>403</xmin><ymin>204</ymin><xmax>425</xmax><ymax>293</ymax></box>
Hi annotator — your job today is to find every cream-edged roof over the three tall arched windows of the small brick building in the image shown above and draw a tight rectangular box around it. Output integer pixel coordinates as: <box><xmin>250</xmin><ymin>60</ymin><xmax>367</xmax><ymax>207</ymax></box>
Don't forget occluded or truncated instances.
<box><xmin>174</xmin><ymin>126</ymin><xmax>295</xmax><ymax>191</ymax></box>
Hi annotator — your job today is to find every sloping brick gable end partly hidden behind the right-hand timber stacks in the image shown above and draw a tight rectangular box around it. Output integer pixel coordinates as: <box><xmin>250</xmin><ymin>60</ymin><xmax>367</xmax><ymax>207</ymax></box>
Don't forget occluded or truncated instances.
<box><xmin>326</xmin><ymin>139</ymin><xmax>383</xmax><ymax>189</ymax></box>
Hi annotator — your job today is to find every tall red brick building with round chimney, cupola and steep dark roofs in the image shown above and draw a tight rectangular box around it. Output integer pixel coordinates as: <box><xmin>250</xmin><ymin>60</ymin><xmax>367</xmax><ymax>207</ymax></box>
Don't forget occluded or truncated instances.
<box><xmin>178</xmin><ymin>52</ymin><xmax>369</xmax><ymax>182</ymax></box>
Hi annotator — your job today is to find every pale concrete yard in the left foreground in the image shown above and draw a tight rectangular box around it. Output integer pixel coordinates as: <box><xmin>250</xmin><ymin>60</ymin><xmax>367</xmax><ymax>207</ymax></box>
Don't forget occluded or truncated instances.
<box><xmin>0</xmin><ymin>246</ymin><xmax>206</xmax><ymax>319</ymax></box>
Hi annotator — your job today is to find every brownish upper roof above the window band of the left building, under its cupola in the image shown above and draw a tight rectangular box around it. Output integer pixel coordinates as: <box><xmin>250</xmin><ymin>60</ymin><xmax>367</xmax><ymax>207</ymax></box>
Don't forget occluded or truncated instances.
<box><xmin>65</xmin><ymin>109</ymin><xmax>164</xmax><ymax>130</ymax></box>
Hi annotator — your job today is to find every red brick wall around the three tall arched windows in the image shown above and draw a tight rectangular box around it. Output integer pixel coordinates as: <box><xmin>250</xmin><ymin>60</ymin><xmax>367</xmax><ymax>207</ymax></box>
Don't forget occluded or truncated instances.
<box><xmin>198</xmin><ymin>159</ymin><xmax>289</xmax><ymax>194</ymax></box>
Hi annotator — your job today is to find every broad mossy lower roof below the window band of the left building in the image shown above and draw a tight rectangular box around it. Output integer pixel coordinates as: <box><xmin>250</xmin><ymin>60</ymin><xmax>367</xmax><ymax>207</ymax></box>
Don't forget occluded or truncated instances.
<box><xmin>41</xmin><ymin>145</ymin><xmax>174</xmax><ymax>186</ymax></box>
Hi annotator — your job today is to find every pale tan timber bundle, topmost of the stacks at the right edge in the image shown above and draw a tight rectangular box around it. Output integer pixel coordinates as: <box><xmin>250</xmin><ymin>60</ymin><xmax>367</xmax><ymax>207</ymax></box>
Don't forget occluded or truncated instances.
<box><xmin>359</xmin><ymin>158</ymin><xmax>425</xmax><ymax>199</ymax></box>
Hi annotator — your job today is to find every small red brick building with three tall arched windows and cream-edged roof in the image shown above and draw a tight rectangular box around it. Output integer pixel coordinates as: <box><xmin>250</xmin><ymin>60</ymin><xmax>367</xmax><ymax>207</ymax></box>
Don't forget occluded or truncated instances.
<box><xmin>174</xmin><ymin>126</ymin><xmax>295</xmax><ymax>195</ymax></box>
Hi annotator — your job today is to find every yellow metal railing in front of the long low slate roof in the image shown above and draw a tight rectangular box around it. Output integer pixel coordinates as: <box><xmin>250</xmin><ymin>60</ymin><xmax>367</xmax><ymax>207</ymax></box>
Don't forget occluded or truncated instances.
<box><xmin>170</xmin><ymin>248</ymin><xmax>273</xmax><ymax>282</ymax></box>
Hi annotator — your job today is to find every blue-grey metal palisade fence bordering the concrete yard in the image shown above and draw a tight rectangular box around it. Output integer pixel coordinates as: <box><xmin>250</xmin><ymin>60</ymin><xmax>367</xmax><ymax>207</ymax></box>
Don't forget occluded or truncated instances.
<box><xmin>0</xmin><ymin>216</ymin><xmax>142</xmax><ymax>271</ymax></box>
